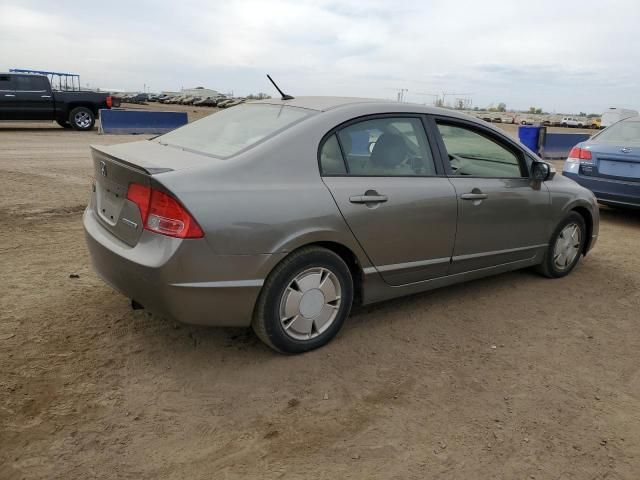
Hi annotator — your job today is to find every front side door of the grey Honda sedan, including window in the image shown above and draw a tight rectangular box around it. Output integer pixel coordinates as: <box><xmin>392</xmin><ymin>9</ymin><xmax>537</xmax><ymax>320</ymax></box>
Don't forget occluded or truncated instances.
<box><xmin>435</xmin><ymin>117</ymin><xmax>550</xmax><ymax>274</ymax></box>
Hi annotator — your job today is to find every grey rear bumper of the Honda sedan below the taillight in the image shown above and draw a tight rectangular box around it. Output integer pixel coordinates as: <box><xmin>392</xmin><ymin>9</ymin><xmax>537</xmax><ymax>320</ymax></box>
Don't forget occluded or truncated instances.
<box><xmin>83</xmin><ymin>208</ymin><xmax>284</xmax><ymax>327</ymax></box>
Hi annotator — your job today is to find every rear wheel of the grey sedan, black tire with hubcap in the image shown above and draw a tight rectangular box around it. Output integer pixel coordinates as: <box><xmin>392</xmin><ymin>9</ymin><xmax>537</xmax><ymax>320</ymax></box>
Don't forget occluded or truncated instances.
<box><xmin>251</xmin><ymin>247</ymin><xmax>353</xmax><ymax>353</ymax></box>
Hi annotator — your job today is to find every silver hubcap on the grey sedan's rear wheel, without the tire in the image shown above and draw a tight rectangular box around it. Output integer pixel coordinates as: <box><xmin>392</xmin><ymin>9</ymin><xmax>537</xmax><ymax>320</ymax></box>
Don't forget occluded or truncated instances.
<box><xmin>280</xmin><ymin>268</ymin><xmax>341</xmax><ymax>340</ymax></box>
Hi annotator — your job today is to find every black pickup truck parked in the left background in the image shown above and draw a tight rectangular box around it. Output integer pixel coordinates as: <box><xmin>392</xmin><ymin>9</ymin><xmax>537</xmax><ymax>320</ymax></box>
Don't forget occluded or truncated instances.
<box><xmin>0</xmin><ymin>73</ymin><xmax>113</xmax><ymax>130</ymax></box>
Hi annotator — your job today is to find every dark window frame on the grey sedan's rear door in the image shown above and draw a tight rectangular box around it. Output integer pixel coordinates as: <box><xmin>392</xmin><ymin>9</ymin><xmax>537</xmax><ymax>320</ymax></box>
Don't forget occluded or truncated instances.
<box><xmin>317</xmin><ymin>112</ymin><xmax>448</xmax><ymax>178</ymax></box>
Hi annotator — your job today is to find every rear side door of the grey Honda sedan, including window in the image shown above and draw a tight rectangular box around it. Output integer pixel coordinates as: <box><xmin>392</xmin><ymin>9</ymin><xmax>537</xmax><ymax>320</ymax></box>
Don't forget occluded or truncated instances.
<box><xmin>319</xmin><ymin>115</ymin><xmax>457</xmax><ymax>285</ymax></box>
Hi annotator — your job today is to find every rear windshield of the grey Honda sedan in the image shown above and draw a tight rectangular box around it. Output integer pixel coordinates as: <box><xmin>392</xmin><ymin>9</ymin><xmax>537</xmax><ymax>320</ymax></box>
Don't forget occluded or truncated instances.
<box><xmin>154</xmin><ymin>104</ymin><xmax>313</xmax><ymax>158</ymax></box>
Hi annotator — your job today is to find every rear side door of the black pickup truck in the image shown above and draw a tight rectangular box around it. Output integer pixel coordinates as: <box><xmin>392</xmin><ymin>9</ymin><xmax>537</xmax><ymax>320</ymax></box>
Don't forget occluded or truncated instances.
<box><xmin>14</xmin><ymin>75</ymin><xmax>54</xmax><ymax>120</ymax></box>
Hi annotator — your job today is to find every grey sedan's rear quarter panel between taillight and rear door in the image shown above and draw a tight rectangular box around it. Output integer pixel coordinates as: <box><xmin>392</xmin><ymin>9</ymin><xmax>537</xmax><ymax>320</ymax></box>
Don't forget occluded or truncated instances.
<box><xmin>154</xmin><ymin>112</ymin><xmax>370</xmax><ymax>267</ymax></box>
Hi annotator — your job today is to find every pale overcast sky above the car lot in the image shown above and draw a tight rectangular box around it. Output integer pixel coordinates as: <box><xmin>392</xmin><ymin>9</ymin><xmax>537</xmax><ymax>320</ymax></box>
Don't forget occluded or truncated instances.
<box><xmin>0</xmin><ymin>0</ymin><xmax>640</xmax><ymax>112</ymax></box>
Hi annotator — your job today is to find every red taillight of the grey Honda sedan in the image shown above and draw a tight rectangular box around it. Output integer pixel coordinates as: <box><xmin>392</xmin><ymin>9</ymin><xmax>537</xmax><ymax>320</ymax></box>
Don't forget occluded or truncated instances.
<box><xmin>127</xmin><ymin>183</ymin><xmax>204</xmax><ymax>238</ymax></box>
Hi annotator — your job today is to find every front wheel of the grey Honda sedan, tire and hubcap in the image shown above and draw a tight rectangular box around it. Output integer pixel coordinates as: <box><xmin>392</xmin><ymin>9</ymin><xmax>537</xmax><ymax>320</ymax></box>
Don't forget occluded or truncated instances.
<box><xmin>537</xmin><ymin>212</ymin><xmax>587</xmax><ymax>278</ymax></box>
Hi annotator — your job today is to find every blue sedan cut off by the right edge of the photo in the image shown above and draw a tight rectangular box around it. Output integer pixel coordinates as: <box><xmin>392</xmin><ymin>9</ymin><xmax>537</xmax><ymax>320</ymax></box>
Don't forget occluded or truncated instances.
<box><xmin>563</xmin><ymin>117</ymin><xmax>640</xmax><ymax>207</ymax></box>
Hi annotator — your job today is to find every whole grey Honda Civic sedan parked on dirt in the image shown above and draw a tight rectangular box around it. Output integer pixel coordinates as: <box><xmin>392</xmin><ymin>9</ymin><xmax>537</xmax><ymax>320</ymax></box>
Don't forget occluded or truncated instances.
<box><xmin>83</xmin><ymin>97</ymin><xmax>599</xmax><ymax>353</ymax></box>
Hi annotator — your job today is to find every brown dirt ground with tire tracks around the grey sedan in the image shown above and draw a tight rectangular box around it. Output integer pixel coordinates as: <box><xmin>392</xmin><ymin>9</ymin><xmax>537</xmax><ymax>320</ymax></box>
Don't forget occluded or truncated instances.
<box><xmin>0</xmin><ymin>107</ymin><xmax>640</xmax><ymax>480</ymax></box>
